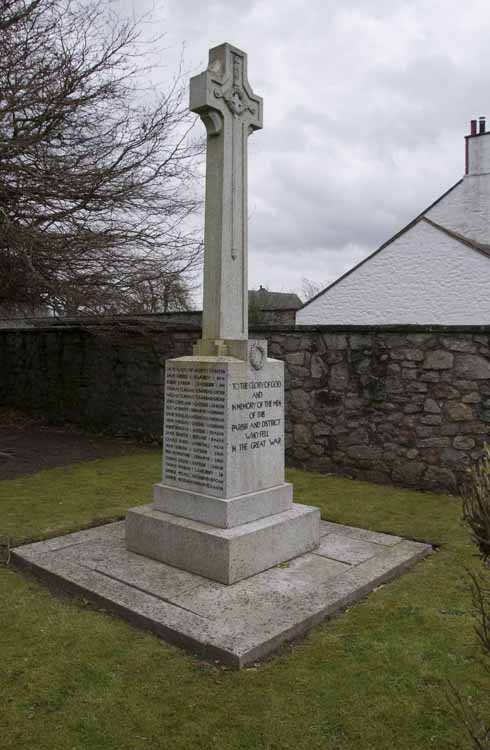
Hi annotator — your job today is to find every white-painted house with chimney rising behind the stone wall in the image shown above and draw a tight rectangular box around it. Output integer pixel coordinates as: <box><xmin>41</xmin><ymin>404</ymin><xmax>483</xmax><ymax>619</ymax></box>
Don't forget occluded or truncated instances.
<box><xmin>296</xmin><ymin>118</ymin><xmax>490</xmax><ymax>325</ymax></box>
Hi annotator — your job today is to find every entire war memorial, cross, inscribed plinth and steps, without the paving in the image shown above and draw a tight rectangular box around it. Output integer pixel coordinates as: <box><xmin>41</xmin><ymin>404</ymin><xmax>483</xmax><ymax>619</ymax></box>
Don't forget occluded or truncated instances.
<box><xmin>126</xmin><ymin>44</ymin><xmax>320</xmax><ymax>584</ymax></box>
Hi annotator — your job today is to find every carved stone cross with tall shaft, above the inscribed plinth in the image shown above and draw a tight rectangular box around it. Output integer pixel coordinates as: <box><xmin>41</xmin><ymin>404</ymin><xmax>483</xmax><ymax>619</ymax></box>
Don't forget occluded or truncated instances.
<box><xmin>190</xmin><ymin>44</ymin><xmax>262</xmax><ymax>356</ymax></box>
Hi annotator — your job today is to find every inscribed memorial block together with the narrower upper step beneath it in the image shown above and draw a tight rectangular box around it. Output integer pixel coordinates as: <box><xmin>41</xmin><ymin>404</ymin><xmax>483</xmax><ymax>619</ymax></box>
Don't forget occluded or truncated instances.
<box><xmin>154</xmin><ymin>357</ymin><xmax>292</xmax><ymax>528</ymax></box>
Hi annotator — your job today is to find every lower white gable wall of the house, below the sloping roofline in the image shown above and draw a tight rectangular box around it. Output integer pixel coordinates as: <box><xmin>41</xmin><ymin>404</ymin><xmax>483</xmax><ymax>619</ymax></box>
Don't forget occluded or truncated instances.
<box><xmin>296</xmin><ymin>217</ymin><xmax>490</xmax><ymax>325</ymax></box>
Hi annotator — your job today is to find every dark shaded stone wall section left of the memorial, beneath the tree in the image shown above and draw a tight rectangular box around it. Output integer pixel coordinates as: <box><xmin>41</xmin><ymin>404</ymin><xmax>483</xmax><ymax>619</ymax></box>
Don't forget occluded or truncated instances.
<box><xmin>0</xmin><ymin>319</ymin><xmax>200</xmax><ymax>437</ymax></box>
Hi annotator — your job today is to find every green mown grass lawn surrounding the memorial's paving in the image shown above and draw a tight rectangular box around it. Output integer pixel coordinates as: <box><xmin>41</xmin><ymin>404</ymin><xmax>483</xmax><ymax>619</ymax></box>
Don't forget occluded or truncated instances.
<box><xmin>0</xmin><ymin>454</ymin><xmax>490</xmax><ymax>750</ymax></box>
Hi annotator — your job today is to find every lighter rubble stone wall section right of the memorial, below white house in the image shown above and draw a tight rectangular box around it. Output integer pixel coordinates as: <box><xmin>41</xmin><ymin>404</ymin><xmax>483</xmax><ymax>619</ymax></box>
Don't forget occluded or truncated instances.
<box><xmin>270</xmin><ymin>328</ymin><xmax>490</xmax><ymax>492</ymax></box>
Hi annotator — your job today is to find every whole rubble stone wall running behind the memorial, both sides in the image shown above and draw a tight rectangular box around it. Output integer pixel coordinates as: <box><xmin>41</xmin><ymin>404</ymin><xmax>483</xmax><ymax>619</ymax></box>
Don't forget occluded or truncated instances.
<box><xmin>0</xmin><ymin>319</ymin><xmax>490</xmax><ymax>492</ymax></box>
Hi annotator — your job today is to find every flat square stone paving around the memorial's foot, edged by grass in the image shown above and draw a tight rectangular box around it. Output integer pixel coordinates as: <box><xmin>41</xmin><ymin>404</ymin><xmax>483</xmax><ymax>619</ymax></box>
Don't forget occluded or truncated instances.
<box><xmin>13</xmin><ymin>522</ymin><xmax>432</xmax><ymax>668</ymax></box>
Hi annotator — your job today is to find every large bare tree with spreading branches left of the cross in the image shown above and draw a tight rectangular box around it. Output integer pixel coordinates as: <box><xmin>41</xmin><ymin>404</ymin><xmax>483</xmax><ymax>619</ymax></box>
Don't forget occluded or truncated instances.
<box><xmin>0</xmin><ymin>0</ymin><xmax>202</xmax><ymax>313</ymax></box>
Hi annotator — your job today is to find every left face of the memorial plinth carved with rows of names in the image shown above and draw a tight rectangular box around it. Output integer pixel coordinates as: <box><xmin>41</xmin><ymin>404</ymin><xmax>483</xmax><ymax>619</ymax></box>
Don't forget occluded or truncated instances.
<box><xmin>163</xmin><ymin>363</ymin><xmax>227</xmax><ymax>495</ymax></box>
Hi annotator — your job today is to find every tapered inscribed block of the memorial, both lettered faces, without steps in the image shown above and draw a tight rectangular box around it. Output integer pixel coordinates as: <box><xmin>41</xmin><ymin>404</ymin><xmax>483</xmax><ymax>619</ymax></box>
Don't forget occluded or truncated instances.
<box><xmin>163</xmin><ymin>358</ymin><xmax>284</xmax><ymax>498</ymax></box>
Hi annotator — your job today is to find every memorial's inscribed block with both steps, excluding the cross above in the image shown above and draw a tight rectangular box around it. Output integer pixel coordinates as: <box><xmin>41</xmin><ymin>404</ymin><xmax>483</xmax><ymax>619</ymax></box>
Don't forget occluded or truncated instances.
<box><xmin>126</xmin><ymin>350</ymin><xmax>320</xmax><ymax>584</ymax></box>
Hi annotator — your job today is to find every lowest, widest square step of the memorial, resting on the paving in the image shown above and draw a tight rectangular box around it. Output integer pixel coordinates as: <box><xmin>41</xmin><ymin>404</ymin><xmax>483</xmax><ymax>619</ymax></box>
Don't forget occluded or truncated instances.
<box><xmin>126</xmin><ymin>504</ymin><xmax>320</xmax><ymax>584</ymax></box>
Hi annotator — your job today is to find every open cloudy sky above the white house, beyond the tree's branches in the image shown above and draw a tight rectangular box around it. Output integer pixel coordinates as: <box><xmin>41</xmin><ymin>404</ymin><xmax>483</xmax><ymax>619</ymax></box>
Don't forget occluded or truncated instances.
<box><xmin>111</xmin><ymin>0</ymin><xmax>490</xmax><ymax>306</ymax></box>
